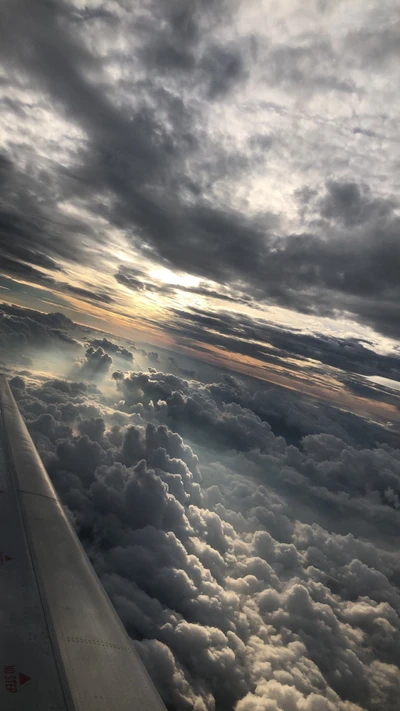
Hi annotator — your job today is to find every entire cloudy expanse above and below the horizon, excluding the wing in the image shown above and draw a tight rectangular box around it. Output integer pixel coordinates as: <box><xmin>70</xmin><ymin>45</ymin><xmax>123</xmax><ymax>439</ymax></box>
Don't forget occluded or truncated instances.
<box><xmin>0</xmin><ymin>0</ymin><xmax>400</xmax><ymax>711</ymax></box>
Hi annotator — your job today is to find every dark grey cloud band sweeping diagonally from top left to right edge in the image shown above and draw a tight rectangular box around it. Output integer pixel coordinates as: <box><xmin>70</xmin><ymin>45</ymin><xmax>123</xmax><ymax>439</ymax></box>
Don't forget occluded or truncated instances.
<box><xmin>2</xmin><ymin>0</ymin><xmax>400</xmax><ymax>335</ymax></box>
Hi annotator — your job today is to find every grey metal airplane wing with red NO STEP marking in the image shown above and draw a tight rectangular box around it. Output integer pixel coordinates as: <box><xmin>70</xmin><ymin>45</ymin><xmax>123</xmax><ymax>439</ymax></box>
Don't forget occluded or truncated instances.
<box><xmin>0</xmin><ymin>376</ymin><xmax>165</xmax><ymax>711</ymax></box>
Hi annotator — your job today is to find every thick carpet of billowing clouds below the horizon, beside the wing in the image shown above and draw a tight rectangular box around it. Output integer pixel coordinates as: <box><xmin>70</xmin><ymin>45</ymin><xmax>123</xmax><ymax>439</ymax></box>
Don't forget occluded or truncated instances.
<box><xmin>7</xmin><ymin>372</ymin><xmax>400</xmax><ymax>711</ymax></box>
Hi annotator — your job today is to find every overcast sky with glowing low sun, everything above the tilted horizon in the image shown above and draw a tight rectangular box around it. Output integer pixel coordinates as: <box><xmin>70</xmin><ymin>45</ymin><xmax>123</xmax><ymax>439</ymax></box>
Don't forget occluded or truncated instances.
<box><xmin>0</xmin><ymin>0</ymin><xmax>400</xmax><ymax>420</ymax></box>
